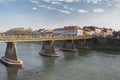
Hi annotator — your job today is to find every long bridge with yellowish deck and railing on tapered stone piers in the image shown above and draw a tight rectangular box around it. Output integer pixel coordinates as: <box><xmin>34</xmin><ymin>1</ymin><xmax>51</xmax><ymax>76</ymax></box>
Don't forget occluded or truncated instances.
<box><xmin>0</xmin><ymin>36</ymin><xmax>92</xmax><ymax>67</ymax></box>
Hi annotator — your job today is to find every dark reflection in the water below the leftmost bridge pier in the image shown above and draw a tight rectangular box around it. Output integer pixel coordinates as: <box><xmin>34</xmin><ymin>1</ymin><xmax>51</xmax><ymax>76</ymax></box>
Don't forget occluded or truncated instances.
<box><xmin>6</xmin><ymin>67</ymin><xmax>18</xmax><ymax>80</ymax></box>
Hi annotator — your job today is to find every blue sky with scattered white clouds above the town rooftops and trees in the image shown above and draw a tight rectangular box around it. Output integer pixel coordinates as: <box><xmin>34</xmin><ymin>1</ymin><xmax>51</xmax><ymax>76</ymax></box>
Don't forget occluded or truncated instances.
<box><xmin>0</xmin><ymin>0</ymin><xmax>120</xmax><ymax>32</ymax></box>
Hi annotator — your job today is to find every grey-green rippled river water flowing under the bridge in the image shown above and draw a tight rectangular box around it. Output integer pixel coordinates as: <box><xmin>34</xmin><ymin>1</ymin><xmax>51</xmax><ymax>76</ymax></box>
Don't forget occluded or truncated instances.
<box><xmin>0</xmin><ymin>43</ymin><xmax>120</xmax><ymax>80</ymax></box>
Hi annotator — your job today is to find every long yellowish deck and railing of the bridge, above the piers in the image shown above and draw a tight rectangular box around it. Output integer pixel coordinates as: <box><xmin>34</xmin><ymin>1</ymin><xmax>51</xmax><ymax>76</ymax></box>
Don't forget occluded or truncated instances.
<box><xmin>0</xmin><ymin>35</ymin><xmax>92</xmax><ymax>42</ymax></box>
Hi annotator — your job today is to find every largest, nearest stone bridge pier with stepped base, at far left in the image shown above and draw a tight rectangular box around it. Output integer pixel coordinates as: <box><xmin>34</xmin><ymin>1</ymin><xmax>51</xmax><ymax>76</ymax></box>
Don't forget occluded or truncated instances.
<box><xmin>0</xmin><ymin>42</ymin><xmax>23</xmax><ymax>67</ymax></box>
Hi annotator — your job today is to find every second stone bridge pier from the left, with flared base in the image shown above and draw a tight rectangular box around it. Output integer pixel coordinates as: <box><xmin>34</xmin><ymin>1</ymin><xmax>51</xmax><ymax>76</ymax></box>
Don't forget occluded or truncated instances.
<box><xmin>39</xmin><ymin>41</ymin><xmax>59</xmax><ymax>57</ymax></box>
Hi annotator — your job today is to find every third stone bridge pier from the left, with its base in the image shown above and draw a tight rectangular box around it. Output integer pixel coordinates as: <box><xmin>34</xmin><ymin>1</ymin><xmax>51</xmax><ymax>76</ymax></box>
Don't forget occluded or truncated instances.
<box><xmin>60</xmin><ymin>40</ymin><xmax>78</xmax><ymax>52</ymax></box>
